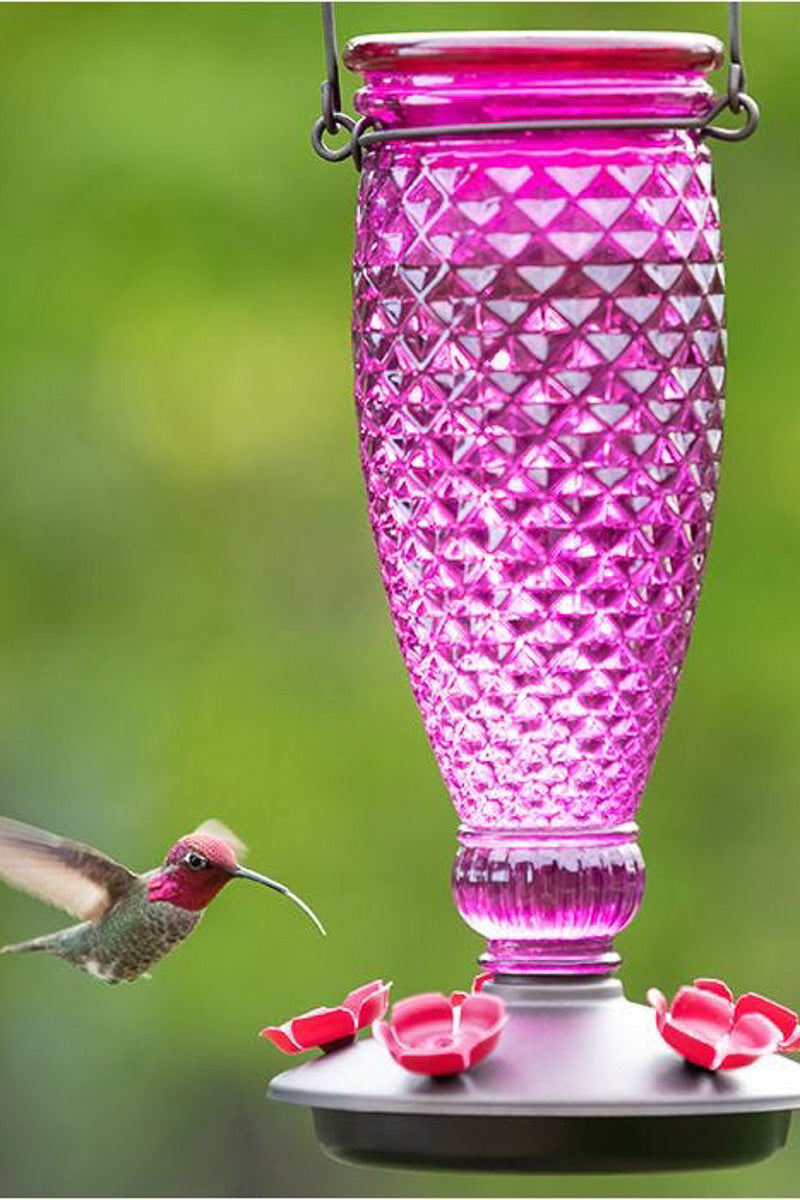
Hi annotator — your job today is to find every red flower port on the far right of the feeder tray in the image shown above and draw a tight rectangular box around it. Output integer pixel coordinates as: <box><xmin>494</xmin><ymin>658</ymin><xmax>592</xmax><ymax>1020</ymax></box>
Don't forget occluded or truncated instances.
<box><xmin>648</xmin><ymin>979</ymin><xmax>800</xmax><ymax>1070</ymax></box>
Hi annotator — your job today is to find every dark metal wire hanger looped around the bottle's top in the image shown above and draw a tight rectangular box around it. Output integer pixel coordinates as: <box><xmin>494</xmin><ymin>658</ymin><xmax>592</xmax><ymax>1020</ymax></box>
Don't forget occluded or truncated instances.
<box><xmin>311</xmin><ymin>0</ymin><xmax>760</xmax><ymax>170</ymax></box>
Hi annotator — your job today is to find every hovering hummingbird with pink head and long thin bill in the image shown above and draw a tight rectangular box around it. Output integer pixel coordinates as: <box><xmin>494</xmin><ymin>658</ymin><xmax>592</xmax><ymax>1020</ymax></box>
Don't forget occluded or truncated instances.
<box><xmin>0</xmin><ymin>817</ymin><xmax>325</xmax><ymax>983</ymax></box>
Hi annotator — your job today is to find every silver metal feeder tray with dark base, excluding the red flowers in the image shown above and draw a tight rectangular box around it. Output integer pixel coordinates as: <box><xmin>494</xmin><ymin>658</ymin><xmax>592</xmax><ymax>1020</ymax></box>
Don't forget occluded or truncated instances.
<box><xmin>269</xmin><ymin>976</ymin><xmax>800</xmax><ymax>1172</ymax></box>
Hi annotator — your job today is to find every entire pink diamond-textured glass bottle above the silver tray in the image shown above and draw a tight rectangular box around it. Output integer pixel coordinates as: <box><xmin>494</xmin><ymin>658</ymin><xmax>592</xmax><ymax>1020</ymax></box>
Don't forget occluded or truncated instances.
<box><xmin>345</xmin><ymin>34</ymin><xmax>726</xmax><ymax>974</ymax></box>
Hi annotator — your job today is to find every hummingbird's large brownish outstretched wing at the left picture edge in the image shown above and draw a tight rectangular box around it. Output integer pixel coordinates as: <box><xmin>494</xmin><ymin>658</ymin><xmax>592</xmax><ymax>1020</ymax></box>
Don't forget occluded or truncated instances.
<box><xmin>0</xmin><ymin>817</ymin><xmax>137</xmax><ymax>920</ymax></box>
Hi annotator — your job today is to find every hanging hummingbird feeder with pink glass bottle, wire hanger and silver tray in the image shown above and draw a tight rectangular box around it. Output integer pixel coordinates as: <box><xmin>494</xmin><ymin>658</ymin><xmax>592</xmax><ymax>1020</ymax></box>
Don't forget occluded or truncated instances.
<box><xmin>271</xmin><ymin>4</ymin><xmax>800</xmax><ymax>1171</ymax></box>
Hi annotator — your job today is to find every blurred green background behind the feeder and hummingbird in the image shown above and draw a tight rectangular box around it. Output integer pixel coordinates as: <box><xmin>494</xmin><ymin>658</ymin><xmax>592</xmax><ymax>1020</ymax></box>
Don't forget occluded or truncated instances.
<box><xmin>0</xmin><ymin>4</ymin><xmax>800</xmax><ymax>1196</ymax></box>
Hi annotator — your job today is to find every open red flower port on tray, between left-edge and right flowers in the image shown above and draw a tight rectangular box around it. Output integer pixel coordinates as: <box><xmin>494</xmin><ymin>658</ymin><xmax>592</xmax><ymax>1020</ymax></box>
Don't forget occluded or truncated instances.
<box><xmin>372</xmin><ymin>991</ymin><xmax>507</xmax><ymax>1075</ymax></box>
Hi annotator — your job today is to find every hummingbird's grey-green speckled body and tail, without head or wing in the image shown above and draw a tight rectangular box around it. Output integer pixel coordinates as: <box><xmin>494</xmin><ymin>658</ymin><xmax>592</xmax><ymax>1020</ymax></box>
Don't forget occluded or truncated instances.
<box><xmin>7</xmin><ymin>871</ymin><xmax>203</xmax><ymax>983</ymax></box>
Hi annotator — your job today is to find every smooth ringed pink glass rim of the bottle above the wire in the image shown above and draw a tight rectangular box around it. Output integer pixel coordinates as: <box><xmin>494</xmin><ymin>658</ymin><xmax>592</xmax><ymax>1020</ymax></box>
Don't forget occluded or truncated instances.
<box><xmin>345</xmin><ymin>34</ymin><xmax>722</xmax><ymax>128</ymax></box>
